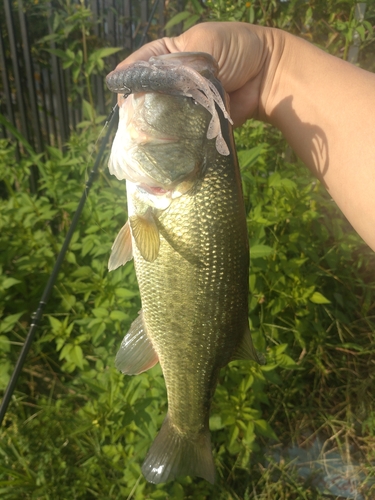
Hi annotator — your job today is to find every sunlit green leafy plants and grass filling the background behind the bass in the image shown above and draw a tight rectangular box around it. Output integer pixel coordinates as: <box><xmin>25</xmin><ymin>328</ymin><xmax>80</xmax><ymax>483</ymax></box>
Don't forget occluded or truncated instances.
<box><xmin>0</xmin><ymin>0</ymin><xmax>375</xmax><ymax>500</ymax></box>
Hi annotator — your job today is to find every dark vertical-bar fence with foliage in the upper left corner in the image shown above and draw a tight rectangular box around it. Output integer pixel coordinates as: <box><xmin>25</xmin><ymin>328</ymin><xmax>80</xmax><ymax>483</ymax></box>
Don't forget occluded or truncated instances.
<box><xmin>0</xmin><ymin>0</ymin><xmax>183</xmax><ymax>176</ymax></box>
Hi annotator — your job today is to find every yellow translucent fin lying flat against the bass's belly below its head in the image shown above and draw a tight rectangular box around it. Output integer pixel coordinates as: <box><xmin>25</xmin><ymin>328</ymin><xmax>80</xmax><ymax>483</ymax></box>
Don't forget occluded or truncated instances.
<box><xmin>129</xmin><ymin>207</ymin><xmax>160</xmax><ymax>262</ymax></box>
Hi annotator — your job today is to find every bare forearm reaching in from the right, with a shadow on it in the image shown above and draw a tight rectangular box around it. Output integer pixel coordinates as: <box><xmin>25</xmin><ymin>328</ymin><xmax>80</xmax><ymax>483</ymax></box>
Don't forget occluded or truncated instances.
<box><xmin>260</xmin><ymin>30</ymin><xmax>375</xmax><ymax>250</ymax></box>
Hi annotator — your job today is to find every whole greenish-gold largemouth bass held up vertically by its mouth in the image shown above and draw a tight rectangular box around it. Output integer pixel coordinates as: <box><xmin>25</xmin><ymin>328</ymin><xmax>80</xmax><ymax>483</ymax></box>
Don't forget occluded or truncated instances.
<box><xmin>107</xmin><ymin>53</ymin><xmax>258</xmax><ymax>483</ymax></box>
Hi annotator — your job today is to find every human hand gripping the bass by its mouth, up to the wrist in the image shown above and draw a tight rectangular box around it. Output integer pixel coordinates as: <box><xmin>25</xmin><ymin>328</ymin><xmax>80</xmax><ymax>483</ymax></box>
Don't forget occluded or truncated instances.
<box><xmin>107</xmin><ymin>22</ymin><xmax>282</xmax><ymax>126</ymax></box>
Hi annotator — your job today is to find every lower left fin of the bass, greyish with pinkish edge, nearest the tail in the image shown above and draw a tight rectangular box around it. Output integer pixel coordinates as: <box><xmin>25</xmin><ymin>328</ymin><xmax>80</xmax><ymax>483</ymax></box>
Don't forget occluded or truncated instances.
<box><xmin>115</xmin><ymin>311</ymin><xmax>159</xmax><ymax>375</ymax></box>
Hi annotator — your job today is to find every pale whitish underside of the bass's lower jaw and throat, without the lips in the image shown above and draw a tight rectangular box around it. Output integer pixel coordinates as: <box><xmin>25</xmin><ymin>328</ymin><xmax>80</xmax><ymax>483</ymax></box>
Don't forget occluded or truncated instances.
<box><xmin>109</xmin><ymin>92</ymin><xmax>211</xmax><ymax>198</ymax></box>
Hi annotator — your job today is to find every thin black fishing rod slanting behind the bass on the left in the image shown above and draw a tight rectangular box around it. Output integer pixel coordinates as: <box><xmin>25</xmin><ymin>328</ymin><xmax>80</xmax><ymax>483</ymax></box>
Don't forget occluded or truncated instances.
<box><xmin>0</xmin><ymin>0</ymin><xmax>159</xmax><ymax>426</ymax></box>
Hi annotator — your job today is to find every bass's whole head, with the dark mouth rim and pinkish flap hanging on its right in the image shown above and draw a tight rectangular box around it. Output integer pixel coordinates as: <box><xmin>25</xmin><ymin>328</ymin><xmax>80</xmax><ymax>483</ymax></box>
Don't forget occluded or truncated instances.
<box><xmin>107</xmin><ymin>52</ymin><xmax>232</xmax><ymax>208</ymax></box>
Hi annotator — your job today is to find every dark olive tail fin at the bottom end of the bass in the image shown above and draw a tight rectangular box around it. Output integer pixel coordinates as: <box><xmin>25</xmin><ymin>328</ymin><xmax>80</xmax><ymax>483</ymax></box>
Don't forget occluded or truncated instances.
<box><xmin>142</xmin><ymin>414</ymin><xmax>215</xmax><ymax>484</ymax></box>
